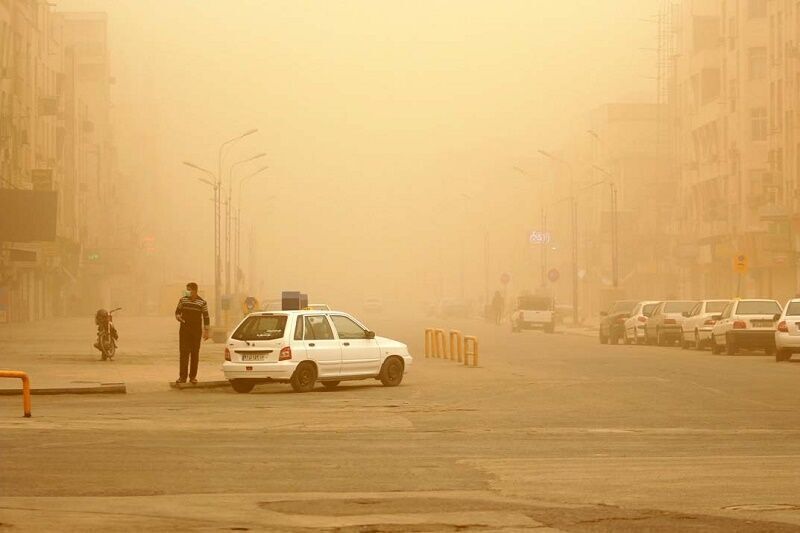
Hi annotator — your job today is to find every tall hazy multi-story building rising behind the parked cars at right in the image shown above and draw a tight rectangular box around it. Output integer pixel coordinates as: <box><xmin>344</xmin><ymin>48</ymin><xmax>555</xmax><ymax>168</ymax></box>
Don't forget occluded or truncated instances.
<box><xmin>673</xmin><ymin>0</ymin><xmax>794</xmax><ymax>297</ymax></box>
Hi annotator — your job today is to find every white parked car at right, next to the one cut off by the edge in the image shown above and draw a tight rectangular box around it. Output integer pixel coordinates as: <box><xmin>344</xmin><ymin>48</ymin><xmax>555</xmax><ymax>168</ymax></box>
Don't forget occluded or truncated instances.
<box><xmin>710</xmin><ymin>300</ymin><xmax>783</xmax><ymax>355</ymax></box>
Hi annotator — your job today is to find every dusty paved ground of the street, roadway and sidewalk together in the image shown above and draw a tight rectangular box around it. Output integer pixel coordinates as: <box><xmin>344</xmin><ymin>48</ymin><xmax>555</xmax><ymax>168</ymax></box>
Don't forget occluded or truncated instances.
<box><xmin>0</xmin><ymin>316</ymin><xmax>800</xmax><ymax>532</ymax></box>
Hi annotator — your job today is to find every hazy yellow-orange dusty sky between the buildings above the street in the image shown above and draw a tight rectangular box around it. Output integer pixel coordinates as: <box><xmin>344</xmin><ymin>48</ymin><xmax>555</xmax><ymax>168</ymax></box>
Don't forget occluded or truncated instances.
<box><xmin>58</xmin><ymin>0</ymin><xmax>659</xmax><ymax>308</ymax></box>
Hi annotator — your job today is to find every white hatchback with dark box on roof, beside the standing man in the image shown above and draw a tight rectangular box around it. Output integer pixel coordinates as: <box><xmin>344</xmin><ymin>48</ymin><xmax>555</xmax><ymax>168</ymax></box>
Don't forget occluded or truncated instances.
<box><xmin>222</xmin><ymin>311</ymin><xmax>412</xmax><ymax>393</ymax></box>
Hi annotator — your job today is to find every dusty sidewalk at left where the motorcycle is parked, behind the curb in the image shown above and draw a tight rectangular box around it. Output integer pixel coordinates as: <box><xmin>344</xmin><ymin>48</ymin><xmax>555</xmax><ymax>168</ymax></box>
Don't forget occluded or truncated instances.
<box><xmin>0</xmin><ymin>313</ymin><xmax>224</xmax><ymax>393</ymax></box>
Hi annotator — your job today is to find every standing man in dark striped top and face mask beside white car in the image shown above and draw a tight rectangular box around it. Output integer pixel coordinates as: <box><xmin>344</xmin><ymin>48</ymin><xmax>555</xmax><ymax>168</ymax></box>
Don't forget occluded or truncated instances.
<box><xmin>175</xmin><ymin>282</ymin><xmax>211</xmax><ymax>383</ymax></box>
